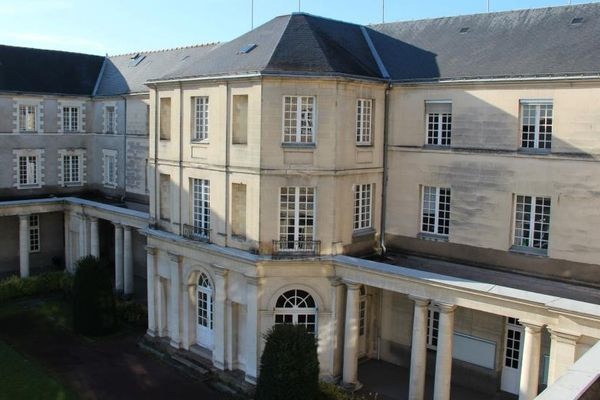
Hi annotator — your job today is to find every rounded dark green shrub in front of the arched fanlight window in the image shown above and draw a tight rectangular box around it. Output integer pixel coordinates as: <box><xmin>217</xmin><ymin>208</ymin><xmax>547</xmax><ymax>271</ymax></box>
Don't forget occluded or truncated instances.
<box><xmin>256</xmin><ymin>325</ymin><xmax>319</xmax><ymax>400</ymax></box>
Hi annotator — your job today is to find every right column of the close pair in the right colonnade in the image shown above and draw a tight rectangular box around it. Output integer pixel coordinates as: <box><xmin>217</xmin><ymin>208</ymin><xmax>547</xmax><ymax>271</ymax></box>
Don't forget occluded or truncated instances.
<box><xmin>433</xmin><ymin>304</ymin><xmax>456</xmax><ymax>400</ymax></box>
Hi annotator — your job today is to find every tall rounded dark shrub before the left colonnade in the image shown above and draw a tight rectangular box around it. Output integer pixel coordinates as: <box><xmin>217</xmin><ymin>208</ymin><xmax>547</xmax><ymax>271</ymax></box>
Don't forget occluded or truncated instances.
<box><xmin>72</xmin><ymin>256</ymin><xmax>116</xmax><ymax>336</ymax></box>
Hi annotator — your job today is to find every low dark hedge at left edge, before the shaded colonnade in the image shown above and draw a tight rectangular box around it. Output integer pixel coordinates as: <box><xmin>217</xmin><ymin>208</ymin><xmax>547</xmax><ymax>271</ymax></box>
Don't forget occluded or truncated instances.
<box><xmin>0</xmin><ymin>272</ymin><xmax>67</xmax><ymax>303</ymax></box>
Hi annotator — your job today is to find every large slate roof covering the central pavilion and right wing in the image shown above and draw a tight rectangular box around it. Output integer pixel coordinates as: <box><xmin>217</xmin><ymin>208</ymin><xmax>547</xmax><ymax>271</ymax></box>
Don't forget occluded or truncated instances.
<box><xmin>161</xmin><ymin>4</ymin><xmax>600</xmax><ymax>81</ymax></box>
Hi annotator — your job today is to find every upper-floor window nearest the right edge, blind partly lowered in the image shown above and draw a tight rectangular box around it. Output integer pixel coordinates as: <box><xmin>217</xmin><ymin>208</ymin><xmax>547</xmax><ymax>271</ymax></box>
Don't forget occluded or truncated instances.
<box><xmin>521</xmin><ymin>101</ymin><xmax>553</xmax><ymax>150</ymax></box>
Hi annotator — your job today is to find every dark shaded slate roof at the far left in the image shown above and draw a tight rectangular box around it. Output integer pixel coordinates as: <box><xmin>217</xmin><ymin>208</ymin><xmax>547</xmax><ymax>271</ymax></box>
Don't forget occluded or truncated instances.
<box><xmin>0</xmin><ymin>45</ymin><xmax>104</xmax><ymax>96</ymax></box>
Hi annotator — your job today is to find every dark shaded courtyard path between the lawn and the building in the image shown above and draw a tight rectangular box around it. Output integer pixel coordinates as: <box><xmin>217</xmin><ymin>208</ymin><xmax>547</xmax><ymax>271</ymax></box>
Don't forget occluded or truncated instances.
<box><xmin>0</xmin><ymin>304</ymin><xmax>229</xmax><ymax>400</ymax></box>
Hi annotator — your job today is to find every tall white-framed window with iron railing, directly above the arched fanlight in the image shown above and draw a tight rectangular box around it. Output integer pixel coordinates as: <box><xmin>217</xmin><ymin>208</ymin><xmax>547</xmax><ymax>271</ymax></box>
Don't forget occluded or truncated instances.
<box><xmin>279</xmin><ymin>186</ymin><xmax>317</xmax><ymax>252</ymax></box>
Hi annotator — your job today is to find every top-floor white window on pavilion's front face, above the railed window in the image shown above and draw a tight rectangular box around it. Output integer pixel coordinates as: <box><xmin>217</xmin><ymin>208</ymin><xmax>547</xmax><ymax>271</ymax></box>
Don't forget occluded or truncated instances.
<box><xmin>283</xmin><ymin>96</ymin><xmax>315</xmax><ymax>144</ymax></box>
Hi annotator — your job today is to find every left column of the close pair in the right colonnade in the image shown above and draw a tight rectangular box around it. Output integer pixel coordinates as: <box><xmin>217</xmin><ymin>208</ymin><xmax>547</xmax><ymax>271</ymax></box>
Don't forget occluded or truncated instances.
<box><xmin>408</xmin><ymin>296</ymin><xmax>429</xmax><ymax>400</ymax></box>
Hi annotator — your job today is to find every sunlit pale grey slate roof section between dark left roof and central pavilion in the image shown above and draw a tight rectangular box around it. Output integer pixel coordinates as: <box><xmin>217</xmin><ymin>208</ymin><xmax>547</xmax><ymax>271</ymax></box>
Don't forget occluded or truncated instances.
<box><xmin>96</xmin><ymin>44</ymin><xmax>217</xmax><ymax>96</ymax></box>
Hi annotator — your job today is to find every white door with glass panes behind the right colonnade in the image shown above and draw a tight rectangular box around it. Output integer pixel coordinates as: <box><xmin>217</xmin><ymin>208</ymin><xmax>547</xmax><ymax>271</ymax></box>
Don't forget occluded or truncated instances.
<box><xmin>500</xmin><ymin>318</ymin><xmax>523</xmax><ymax>394</ymax></box>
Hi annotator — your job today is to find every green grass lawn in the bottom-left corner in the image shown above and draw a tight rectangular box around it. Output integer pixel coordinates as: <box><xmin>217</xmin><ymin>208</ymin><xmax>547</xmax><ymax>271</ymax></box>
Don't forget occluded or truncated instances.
<box><xmin>0</xmin><ymin>341</ymin><xmax>77</xmax><ymax>400</ymax></box>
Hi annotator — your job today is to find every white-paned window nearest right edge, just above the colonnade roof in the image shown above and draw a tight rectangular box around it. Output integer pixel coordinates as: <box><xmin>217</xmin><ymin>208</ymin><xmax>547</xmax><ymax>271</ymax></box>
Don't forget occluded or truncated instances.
<box><xmin>514</xmin><ymin>195</ymin><xmax>551</xmax><ymax>250</ymax></box>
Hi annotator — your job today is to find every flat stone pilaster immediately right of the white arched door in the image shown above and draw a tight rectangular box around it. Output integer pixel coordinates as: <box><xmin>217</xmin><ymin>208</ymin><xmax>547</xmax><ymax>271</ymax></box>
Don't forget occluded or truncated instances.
<box><xmin>213</xmin><ymin>267</ymin><xmax>228</xmax><ymax>370</ymax></box>
